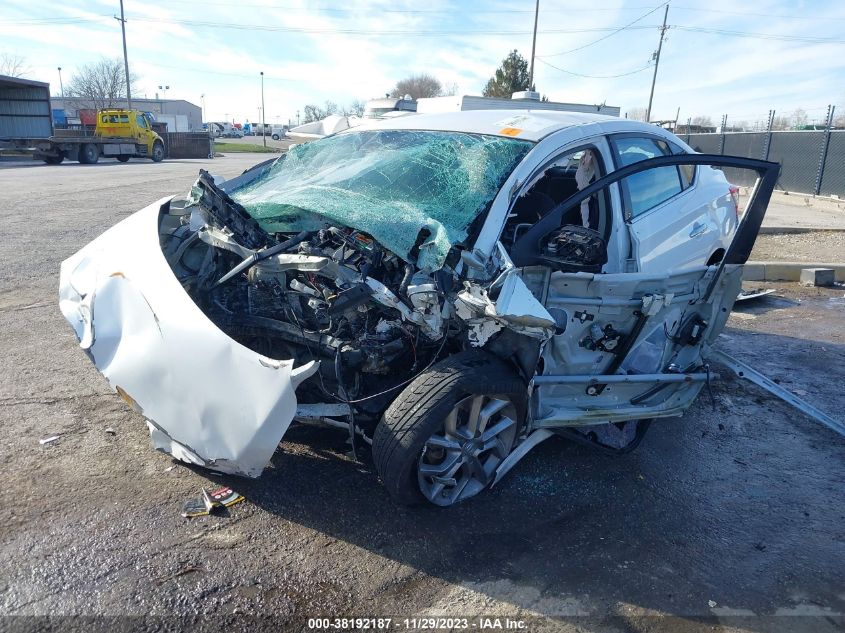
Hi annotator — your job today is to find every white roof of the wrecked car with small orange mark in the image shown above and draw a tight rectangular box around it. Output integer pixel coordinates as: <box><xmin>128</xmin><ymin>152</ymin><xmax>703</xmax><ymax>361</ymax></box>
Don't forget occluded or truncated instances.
<box><xmin>349</xmin><ymin>110</ymin><xmax>648</xmax><ymax>141</ymax></box>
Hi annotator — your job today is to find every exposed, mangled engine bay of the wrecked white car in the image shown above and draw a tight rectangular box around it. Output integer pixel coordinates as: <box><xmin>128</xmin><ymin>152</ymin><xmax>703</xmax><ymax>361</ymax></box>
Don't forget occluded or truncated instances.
<box><xmin>162</xmin><ymin>177</ymin><xmax>553</xmax><ymax>428</ymax></box>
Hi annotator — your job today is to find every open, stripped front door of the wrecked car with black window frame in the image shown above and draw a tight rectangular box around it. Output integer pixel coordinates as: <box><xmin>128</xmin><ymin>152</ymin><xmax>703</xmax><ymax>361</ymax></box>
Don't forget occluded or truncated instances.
<box><xmin>511</xmin><ymin>154</ymin><xmax>779</xmax><ymax>430</ymax></box>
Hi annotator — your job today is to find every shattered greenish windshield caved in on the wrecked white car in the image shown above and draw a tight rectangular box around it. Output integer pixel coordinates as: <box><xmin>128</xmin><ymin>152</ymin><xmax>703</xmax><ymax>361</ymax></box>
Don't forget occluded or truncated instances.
<box><xmin>231</xmin><ymin>130</ymin><xmax>533</xmax><ymax>271</ymax></box>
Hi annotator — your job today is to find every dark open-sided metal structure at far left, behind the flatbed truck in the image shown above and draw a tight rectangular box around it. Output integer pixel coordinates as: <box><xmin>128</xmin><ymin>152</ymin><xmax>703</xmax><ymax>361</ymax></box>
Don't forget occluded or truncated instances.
<box><xmin>0</xmin><ymin>75</ymin><xmax>53</xmax><ymax>139</ymax></box>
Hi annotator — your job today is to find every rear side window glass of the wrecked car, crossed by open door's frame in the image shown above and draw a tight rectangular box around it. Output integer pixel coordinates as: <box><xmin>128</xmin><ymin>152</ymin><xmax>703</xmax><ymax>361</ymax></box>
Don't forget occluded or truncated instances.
<box><xmin>612</xmin><ymin>137</ymin><xmax>688</xmax><ymax>218</ymax></box>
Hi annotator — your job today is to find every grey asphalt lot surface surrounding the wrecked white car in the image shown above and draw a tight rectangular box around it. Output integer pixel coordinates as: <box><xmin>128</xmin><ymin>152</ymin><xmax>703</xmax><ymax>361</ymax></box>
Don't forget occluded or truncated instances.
<box><xmin>0</xmin><ymin>155</ymin><xmax>845</xmax><ymax>633</ymax></box>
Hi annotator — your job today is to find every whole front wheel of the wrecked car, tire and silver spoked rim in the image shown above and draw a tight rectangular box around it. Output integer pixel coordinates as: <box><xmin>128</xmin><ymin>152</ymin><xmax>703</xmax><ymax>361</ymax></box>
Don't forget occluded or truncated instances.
<box><xmin>373</xmin><ymin>351</ymin><xmax>526</xmax><ymax>506</ymax></box>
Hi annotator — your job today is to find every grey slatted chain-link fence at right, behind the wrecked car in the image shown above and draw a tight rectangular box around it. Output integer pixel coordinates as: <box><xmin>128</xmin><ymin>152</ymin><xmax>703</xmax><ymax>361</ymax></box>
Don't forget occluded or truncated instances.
<box><xmin>680</xmin><ymin>130</ymin><xmax>845</xmax><ymax>197</ymax></box>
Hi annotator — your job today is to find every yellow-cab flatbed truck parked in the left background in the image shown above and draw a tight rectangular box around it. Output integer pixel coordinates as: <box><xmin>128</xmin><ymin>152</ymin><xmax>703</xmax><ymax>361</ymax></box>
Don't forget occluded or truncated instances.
<box><xmin>0</xmin><ymin>109</ymin><xmax>164</xmax><ymax>165</ymax></box>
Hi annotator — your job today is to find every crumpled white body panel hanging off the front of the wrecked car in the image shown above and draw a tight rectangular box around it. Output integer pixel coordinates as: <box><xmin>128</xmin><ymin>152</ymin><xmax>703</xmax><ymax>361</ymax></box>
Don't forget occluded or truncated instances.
<box><xmin>59</xmin><ymin>198</ymin><xmax>317</xmax><ymax>477</ymax></box>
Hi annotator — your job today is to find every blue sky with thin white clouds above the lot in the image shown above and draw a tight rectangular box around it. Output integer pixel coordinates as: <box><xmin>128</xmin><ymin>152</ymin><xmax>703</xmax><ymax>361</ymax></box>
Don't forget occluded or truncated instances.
<box><xmin>0</xmin><ymin>0</ymin><xmax>845</xmax><ymax>123</ymax></box>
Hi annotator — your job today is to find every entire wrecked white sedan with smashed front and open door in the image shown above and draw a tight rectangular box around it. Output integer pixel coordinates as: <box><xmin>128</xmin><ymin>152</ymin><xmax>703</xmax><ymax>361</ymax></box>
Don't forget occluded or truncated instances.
<box><xmin>60</xmin><ymin>111</ymin><xmax>777</xmax><ymax>506</ymax></box>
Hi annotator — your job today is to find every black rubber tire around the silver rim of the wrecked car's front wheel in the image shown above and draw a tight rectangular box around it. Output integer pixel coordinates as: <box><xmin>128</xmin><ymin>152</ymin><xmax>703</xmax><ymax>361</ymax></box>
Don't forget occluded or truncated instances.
<box><xmin>373</xmin><ymin>350</ymin><xmax>527</xmax><ymax>505</ymax></box>
